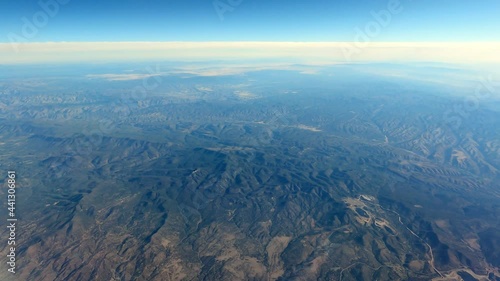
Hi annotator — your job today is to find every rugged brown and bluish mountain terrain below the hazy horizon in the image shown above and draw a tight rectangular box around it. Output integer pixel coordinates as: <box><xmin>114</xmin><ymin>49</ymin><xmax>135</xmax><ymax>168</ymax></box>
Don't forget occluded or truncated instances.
<box><xmin>0</xmin><ymin>62</ymin><xmax>500</xmax><ymax>281</ymax></box>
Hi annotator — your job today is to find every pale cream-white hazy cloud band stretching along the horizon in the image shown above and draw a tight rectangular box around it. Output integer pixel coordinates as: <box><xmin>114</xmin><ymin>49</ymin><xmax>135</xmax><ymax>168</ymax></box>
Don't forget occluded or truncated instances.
<box><xmin>0</xmin><ymin>42</ymin><xmax>500</xmax><ymax>64</ymax></box>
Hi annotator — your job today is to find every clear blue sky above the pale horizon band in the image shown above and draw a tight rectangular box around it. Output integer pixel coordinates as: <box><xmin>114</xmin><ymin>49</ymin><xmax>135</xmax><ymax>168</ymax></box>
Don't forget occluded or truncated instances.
<box><xmin>0</xmin><ymin>0</ymin><xmax>500</xmax><ymax>42</ymax></box>
